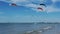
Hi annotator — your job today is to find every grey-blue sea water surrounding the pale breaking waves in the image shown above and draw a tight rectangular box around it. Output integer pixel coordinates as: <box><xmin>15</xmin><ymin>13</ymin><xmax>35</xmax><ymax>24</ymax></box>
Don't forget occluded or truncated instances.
<box><xmin>0</xmin><ymin>23</ymin><xmax>60</xmax><ymax>34</ymax></box>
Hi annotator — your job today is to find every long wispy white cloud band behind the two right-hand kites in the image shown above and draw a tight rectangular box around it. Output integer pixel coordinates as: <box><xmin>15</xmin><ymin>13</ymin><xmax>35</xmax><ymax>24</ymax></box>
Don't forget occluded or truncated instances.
<box><xmin>21</xmin><ymin>3</ymin><xmax>60</xmax><ymax>13</ymax></box>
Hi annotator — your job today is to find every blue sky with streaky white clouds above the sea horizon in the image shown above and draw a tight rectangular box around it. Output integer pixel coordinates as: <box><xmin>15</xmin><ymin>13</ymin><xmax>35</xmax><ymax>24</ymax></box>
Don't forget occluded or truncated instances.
<box><xmin>0</xmin><ymin>0</ymin><xmax>60</xmax><ymax>23</ymax></box>
